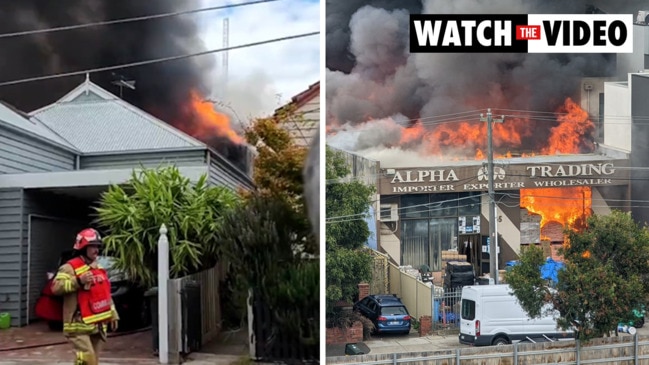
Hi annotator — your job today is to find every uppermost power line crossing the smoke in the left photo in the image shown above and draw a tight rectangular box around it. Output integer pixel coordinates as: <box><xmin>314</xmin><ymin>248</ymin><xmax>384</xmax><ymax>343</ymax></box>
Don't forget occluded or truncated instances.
<box><xmin>0</xmin><ymin>0</ymin><xmax>279</xmax><ymax>38</ymax></box>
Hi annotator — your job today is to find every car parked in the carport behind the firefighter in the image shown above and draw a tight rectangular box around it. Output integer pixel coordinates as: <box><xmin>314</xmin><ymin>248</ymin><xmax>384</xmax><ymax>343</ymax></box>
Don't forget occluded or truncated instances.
<box><xmin>35</xmin><ymin>251</ymin><xmax>151</xmax><ymax>330</ymax></box>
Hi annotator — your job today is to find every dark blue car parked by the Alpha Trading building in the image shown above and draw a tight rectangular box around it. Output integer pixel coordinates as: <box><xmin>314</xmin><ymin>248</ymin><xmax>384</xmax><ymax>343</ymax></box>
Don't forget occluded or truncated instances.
<box><xmin>354</xmin><ymin>295</ymin><xmax>411</xmax><ymax>334</ymax></box>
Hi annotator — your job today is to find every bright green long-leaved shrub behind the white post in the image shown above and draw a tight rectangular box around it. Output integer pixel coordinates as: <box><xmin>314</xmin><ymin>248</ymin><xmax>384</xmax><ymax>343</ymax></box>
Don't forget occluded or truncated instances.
<box><xmin>95</xmin><ymin>166</ymin><xmax>239</xmax><ymax>287</ymax></box>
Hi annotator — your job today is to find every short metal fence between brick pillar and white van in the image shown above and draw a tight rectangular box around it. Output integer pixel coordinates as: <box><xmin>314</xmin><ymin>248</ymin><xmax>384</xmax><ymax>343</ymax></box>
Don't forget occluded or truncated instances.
<box><xmin>432</xmin><ymin>286</ymin><xmax>462</xmax><ymax>334</ymax></box>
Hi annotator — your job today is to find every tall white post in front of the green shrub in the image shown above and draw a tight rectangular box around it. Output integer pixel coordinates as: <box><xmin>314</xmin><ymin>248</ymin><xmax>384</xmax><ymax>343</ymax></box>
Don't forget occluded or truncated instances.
<box><xmin>158</xmin><ymin>223</ymin><xmax>169</xmax><ymax>364</ymax></box>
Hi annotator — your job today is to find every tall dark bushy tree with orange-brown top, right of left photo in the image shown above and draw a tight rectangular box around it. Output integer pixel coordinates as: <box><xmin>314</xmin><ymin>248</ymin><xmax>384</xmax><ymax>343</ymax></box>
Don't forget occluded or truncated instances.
<box><xmin>219</xmin><ymin>104</ymin><xmax>320</xmax><ymax>348</ymax></box>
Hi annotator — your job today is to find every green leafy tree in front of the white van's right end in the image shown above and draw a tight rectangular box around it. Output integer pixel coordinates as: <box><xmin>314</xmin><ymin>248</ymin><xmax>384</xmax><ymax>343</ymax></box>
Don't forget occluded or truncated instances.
<box><xmin>507</xmin><ymin>211</ymin><xmax>649</xmax><ymax>340</ymax></box>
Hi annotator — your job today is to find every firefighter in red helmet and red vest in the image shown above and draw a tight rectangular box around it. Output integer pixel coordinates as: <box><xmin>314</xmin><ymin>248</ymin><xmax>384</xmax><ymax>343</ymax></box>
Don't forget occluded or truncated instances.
<box><xmin>52</xmin><ymin>228</ymin><xmax>119</xmax><ymax>365</ymax></box>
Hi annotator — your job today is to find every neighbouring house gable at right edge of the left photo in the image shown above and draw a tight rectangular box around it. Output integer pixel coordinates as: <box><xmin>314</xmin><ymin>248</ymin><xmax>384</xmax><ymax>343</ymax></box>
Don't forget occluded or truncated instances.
<box><xmin>275</xmin><ymin>81</ymin><xmax>320</xmax><ymax>146</ymax></box>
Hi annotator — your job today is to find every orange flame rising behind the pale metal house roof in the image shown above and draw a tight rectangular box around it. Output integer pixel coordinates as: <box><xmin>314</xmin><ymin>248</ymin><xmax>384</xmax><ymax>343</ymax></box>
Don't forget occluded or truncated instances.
<box><xmin>177</xmin><ymin>90</ymin><xmax>243</xmax><ymax>144</ymax></box>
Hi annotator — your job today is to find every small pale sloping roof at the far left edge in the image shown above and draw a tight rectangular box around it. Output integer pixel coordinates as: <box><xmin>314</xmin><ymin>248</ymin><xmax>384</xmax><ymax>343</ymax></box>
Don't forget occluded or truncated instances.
<box><xmin>0</xmin><ymin>101</ymin><xmax>76</xmax><ymax>152</ymax></box>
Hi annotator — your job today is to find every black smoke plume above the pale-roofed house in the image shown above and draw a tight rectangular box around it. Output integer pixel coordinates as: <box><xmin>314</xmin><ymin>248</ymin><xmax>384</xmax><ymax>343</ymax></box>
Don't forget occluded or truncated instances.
<box><xmin>0</xmin><ymin>0</ymin><xmax>247</xmax><ymax>166</ymax></box>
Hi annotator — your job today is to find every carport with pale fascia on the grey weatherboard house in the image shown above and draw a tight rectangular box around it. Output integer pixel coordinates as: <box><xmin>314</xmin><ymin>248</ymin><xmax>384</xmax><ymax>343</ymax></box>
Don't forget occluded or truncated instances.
<box><xmin>0</xmin><ymin>167</ymin><xmax>207</xmax><ymax>324</ymax></box>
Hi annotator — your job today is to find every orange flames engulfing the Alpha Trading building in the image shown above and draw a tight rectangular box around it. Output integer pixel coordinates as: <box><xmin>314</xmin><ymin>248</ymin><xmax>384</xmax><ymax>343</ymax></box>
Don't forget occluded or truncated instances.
<box><xmin>328</xmin><ymin>98</ymin><xmax>595</xmax><ymax>242</ymax></box>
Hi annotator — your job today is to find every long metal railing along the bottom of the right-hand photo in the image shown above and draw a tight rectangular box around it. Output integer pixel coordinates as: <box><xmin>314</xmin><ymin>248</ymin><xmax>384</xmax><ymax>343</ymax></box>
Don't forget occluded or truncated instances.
<box><xmin>326</xmin><ymin>335</ymin><xmax>649</xmax><ymax>365</ymax></box>
